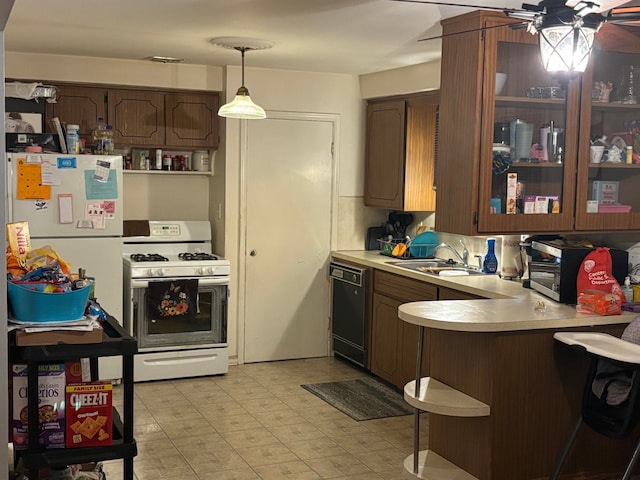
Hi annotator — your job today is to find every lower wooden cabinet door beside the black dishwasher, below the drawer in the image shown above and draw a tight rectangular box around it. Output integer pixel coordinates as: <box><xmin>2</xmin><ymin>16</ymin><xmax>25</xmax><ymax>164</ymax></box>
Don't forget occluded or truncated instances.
<box><xmin>371</xmin><ymin>293</ymin><xmax>404</xmax><ymax>385</ymax></box>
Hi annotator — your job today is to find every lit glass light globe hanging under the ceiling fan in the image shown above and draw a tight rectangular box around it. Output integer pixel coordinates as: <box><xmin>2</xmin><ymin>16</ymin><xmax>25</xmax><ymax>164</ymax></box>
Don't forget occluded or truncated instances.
<box><xmin>539</xmin><ymin>25</ymin><xmax>597</xmax><ymax>74</ymax></box>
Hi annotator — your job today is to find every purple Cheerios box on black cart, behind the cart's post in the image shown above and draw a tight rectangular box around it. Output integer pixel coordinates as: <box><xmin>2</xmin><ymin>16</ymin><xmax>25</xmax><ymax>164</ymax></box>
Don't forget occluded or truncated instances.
<box><xmin>11</xmin><ymin>363</ymin><xmax>65</xmax><ymax>450</ymax></box>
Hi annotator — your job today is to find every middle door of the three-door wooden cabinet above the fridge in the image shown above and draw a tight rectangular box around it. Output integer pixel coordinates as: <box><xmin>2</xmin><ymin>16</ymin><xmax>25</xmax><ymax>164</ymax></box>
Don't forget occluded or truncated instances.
<box><xmin>108</xmin><ymin>90</ymin><xmax>165</xmax><ymax>146</ymax></box>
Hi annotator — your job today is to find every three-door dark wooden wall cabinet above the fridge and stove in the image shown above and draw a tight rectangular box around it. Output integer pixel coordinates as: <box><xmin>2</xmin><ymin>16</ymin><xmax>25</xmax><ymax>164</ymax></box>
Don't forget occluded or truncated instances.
<box><xmin>46</xmin><ymin>82</ymin><xmax>220</xmax><ymax>149</ymax></box>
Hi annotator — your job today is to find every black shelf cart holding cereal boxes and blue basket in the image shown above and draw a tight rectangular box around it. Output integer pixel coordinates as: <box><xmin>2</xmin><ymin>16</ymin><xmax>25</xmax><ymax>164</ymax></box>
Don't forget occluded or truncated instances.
<box><xmin>9</xmin><ymin>317</ymin><xmax>138</xmax><ymax>480</ymax></box>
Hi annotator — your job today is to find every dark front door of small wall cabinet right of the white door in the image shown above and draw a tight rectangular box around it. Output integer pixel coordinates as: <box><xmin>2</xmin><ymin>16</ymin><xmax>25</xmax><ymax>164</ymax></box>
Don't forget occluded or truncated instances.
<box><xmin>364</xmin><ymin>100</ymin><xmax>405</xmax><ymax>210</ymax></box>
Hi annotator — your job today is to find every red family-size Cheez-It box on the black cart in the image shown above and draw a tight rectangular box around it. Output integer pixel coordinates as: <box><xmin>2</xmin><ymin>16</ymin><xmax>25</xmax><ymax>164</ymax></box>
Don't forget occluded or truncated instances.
<box><xmin>67</xmin><ymin>382</ymin><xmax>113</xmax><ymax>447</ymax></box>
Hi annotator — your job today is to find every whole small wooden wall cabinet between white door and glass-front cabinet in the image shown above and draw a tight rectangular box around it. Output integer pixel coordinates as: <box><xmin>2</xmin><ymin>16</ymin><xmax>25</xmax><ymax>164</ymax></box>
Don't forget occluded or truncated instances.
<box><xmin>364</xmin><ymin>91</ymin><xmax>440</xmax><ymax>211</ymax></box>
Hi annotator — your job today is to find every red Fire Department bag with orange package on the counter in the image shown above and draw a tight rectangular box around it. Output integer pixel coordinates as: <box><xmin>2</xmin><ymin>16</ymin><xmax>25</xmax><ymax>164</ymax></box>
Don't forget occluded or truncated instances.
<box><xmin>576</xmin><ymin>247</ymin><xmax>624</xmax><ymax>315</ymax></box>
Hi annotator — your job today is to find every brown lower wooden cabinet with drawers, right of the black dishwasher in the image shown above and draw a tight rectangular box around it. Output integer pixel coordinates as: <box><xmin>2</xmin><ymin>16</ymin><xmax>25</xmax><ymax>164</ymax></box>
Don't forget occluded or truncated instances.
<box><xmin>370</xmin><ymin>270</ymin><xmax>438</xmax><ymax>388</ymax></box>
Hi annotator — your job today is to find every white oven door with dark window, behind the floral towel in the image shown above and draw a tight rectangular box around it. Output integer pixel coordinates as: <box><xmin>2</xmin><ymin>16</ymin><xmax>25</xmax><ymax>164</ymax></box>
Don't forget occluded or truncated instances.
<box><xmin>131</xmin><ymin>277</ymin><xmax>229</xmax><ymax>351</ymax></box>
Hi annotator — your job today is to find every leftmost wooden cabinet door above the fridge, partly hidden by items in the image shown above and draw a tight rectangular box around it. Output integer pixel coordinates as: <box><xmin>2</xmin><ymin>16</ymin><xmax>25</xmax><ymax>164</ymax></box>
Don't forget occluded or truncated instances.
<box><xmin>46</xmin><ymin>85</ymin><xmax>107</xmax><ymax>141</ymax></box>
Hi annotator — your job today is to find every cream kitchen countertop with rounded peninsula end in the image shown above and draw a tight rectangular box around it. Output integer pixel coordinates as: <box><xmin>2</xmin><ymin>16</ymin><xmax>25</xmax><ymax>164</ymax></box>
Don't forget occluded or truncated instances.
<box><xmin>331</xmin><ymin>251</ymin><xmax>636</xmax><ymax>332</ymax></box>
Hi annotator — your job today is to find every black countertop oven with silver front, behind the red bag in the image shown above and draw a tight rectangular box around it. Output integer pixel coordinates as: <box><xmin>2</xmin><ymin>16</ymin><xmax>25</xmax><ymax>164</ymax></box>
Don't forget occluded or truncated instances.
<box><xmin>529</xmin><ymin>240</ymin><xmax>629</xmax><ymax>305</ymax></box>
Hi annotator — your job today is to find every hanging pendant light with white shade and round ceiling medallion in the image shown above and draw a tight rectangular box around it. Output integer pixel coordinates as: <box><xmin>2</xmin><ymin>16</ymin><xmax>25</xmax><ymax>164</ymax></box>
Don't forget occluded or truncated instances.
<box><xmin>210</xmin><ymin>37</ymin><xmax>273</xmax><ymax>120</ymax></box>
